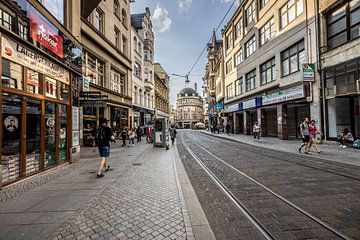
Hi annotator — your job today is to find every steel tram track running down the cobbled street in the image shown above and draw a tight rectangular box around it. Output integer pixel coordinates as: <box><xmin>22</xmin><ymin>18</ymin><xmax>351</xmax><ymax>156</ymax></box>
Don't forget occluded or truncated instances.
<box><xmin>179</xmin><ymin>131</ymin><xmax>357</xmax><ymax>240</ymax></box>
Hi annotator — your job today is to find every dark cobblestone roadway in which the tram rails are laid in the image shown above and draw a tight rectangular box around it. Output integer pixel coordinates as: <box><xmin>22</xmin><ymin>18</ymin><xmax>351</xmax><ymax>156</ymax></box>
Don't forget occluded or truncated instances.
<box><xmin>179</xmin><ymin>131</ymin><xmax>360</xmax><ymax>239</ymax></box>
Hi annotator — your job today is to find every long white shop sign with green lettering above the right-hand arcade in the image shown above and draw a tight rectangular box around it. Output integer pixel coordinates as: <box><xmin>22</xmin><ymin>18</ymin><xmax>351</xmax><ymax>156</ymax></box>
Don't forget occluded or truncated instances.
<box><xmin>262</xmin><ymin>85</ymin><xmax>305</xmax><ymax>105</ymax></box>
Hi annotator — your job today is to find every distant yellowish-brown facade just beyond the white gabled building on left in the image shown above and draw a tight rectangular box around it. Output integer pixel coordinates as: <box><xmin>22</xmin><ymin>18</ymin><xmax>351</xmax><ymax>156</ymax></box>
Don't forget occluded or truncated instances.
<box><xmin>154</xmin><ymin>63</ymin><xmax>170</xmax><ymax>119</ymax></box>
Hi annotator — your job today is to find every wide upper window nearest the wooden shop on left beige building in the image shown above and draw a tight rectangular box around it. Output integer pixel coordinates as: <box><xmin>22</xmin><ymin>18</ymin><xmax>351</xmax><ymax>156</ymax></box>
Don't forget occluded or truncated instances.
<box><xmin>82</xmin><ymin>51</ymin><xmax>105</xmax><ymax>86</ymax></box>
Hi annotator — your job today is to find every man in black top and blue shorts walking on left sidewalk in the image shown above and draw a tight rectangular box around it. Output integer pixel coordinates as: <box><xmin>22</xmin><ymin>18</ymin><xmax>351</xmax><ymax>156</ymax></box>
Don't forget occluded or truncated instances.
<box><xmin>93</xmin><ymin>118</ymin><xmax>115</xmax><ymax>178</ymax></box>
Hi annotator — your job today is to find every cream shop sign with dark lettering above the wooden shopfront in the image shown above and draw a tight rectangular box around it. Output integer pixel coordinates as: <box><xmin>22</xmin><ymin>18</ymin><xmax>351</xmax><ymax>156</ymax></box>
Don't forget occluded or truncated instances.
<box><xmin>1</xmin><ymin>37</ymin><xmax>70</xmax><ymax>84</ymax></box>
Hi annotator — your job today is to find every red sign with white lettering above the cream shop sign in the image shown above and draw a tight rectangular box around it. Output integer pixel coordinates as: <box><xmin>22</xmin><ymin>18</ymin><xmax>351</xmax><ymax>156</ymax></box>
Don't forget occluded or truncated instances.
<box><xmin>29</xmin><ymin>11</ymin><xmax>64</xmax><ymax>58</ymax></box>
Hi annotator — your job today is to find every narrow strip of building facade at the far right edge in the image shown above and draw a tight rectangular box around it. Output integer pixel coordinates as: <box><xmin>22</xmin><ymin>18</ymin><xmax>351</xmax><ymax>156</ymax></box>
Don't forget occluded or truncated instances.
<box><xmin>319</xmin><ymin>0</ymin><xmax>360</xmax><ymax>139</ymax></box>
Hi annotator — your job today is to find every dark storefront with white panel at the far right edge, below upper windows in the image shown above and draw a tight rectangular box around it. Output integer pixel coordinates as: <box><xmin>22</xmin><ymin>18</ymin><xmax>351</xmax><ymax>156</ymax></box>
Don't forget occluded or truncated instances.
<box><xmin>324</xmin><ymin>58</ymin><xmax>360</xmax><ymax>140</ymax></box>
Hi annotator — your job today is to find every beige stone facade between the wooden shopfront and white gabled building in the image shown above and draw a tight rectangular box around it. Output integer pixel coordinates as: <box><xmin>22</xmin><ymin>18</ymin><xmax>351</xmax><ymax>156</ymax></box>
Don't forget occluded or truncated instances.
<box><xmin>80</xmin><ymin>0</ymin><xmax>132</xmax><ymax>143</ymax></box>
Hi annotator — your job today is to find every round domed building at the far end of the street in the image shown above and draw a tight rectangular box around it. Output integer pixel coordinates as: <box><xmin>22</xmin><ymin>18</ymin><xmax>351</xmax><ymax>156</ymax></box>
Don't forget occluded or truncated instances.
<box><xmin>175</xmin><ymin>84</ymin><xmax>204</xmax><ymax>129</ymax></box>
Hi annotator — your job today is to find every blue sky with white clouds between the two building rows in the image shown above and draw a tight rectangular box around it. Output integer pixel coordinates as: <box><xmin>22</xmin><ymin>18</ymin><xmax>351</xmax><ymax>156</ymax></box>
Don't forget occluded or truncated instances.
<box><xmin>131</xmin><ymin>0</ymin><xmax>236</xmax><ymax>106</ymax></box>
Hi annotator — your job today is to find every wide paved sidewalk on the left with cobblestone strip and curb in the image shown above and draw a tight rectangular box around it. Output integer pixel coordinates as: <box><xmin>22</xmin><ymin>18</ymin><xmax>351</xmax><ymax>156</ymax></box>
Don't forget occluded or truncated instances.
<box><xmin>0</xmin><ymin>143</ymin><xmax>213</xmax><ymax>239</ymax></box>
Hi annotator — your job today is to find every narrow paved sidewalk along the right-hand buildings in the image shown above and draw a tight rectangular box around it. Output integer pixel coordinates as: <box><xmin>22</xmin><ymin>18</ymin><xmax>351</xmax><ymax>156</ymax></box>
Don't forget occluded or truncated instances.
<box><xmin>201</xmin><ymin>130</ymin><xmax>360</xmax><ymax>166</ymax></box>
